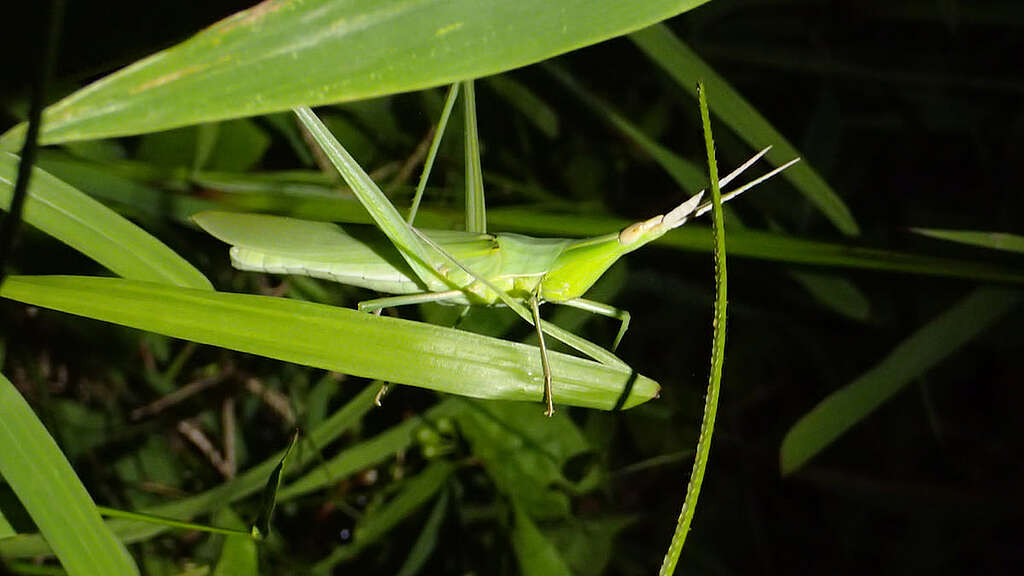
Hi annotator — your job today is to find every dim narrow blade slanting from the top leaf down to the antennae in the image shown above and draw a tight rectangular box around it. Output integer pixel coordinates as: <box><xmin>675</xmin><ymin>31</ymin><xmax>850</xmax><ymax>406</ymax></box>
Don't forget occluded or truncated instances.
<box><xmin>544</xmin><ymin>63</ymin><xmax>705</xmax><ymax>194</ymax></box>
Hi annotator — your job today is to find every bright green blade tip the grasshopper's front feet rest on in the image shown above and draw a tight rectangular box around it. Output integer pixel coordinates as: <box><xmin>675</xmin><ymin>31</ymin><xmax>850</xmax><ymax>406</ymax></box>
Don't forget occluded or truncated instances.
<box><xmin>0</xmin><ymin>276</ymin><xmax>658</xmax><ymax>410</ymax></box>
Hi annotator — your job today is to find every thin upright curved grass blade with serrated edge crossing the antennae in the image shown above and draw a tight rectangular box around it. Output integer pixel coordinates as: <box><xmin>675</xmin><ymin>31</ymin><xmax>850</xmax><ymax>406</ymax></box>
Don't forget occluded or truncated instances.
<box><xmin>659</xmin><ymin>83</ymin><xmax>728</xmax><ymax>576</ymax></box>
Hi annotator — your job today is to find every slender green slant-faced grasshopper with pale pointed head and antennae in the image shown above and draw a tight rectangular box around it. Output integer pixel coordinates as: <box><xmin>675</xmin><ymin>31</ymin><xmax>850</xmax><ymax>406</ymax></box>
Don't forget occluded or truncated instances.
<box><xmin>194</xmin><ymin>89</ymin><xmax>799</xmax><ymax>416</ymax></box>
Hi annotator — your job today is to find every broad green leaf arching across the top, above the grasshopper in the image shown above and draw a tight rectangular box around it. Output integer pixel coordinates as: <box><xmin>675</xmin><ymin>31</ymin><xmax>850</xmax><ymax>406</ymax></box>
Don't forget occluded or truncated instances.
<box><xmin>0</xmin><ymin>0</ymin><xmax>706</xmax><ymax>150</ymax></box>
